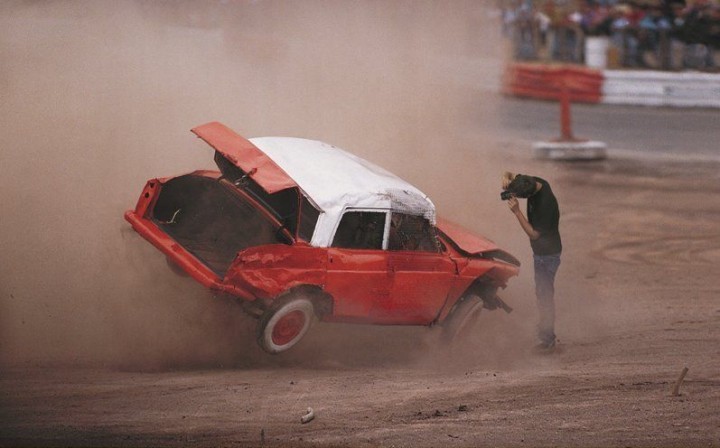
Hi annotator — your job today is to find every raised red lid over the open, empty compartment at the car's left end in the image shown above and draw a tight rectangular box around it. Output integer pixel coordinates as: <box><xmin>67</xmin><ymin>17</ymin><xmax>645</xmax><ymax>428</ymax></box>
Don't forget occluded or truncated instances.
<box><xmin>192</xmin><ymin>122</ymin><xmax>297</xmax><ymax>194</ymax></box>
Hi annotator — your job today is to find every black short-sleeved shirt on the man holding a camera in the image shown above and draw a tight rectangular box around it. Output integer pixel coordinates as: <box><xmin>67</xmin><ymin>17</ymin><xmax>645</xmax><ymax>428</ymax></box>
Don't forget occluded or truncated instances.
<box><xmin>527</xmin><ymin>177</ymin><xmax>562</xmax><ymax>255</ymax></box>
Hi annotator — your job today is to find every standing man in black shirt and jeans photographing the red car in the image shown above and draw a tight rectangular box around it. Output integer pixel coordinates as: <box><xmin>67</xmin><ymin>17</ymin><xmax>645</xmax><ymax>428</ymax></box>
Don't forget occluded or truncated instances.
<box><xmin>501</xmin><ymin>172</ymin><xmax>562</xmax><ymax>351</ymax></box>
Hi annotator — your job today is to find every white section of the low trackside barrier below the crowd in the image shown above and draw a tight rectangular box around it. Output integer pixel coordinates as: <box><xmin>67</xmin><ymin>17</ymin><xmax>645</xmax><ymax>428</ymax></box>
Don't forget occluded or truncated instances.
<box><xmin>602</xmin><ymin>70</ymin><xmax>720</xmax><ymax>108</ymax></box>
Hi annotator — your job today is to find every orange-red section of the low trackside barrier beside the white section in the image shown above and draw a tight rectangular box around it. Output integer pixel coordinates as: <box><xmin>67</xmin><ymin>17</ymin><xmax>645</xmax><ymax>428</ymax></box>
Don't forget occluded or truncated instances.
<box><xmin>503</xmin><ymin>63</ymin><xmax>604</xmax><ymax>103</ymax></box>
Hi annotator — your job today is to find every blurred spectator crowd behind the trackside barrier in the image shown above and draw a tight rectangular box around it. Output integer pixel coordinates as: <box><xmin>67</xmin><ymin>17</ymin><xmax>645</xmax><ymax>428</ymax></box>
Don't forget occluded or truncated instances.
<box><xmin>500</xmin><ymin>0</ymin><xmax>720</xmax><ymax>71</ymax></box>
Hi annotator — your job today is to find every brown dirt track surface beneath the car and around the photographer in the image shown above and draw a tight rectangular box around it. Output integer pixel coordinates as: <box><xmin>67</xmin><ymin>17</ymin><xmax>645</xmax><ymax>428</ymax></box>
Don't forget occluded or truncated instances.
<box><xmin>0</xmin><ymin>152</ymin><xmax>720</xmax><ymax>446</ymax></box>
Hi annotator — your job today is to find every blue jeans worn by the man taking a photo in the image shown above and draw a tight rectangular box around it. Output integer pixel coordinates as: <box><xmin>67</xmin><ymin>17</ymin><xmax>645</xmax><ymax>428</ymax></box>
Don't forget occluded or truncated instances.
<box><xmin>533</xmin><ymin>254</ymin><xmax>560</xmax><ymax>344</ymax></box>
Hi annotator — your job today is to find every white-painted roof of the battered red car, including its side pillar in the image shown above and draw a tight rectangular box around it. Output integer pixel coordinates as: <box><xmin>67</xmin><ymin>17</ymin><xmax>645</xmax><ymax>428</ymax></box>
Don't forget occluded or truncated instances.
<box><xmin>249</xmin><ymin>137</ymin><xmax>435</xmax><ymax>247</ymax></box>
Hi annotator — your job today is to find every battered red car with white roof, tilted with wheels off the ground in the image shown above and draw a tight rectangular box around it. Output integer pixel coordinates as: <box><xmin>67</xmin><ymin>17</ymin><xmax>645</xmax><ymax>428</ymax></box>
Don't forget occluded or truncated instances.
<box><xmin>125</xmin><ymin>123</ymin><xmax>520</xmax><ymax>353</ymax></box>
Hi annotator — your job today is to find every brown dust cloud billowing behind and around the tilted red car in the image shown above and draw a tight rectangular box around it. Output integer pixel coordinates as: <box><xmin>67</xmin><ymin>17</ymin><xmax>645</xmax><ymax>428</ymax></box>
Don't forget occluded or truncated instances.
<box><xmin>0</xmin><ymin>0</ymin><xmax>532</xmax><ymax>368</ymax></box>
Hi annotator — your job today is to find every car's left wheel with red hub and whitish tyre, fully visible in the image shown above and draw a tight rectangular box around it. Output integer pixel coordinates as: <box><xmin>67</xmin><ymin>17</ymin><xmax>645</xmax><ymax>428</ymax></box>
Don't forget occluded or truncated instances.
<box><xmin>258</xmin><ymin>295</ymin><xmax>315</xmax><ymax>354</ymax></box>
